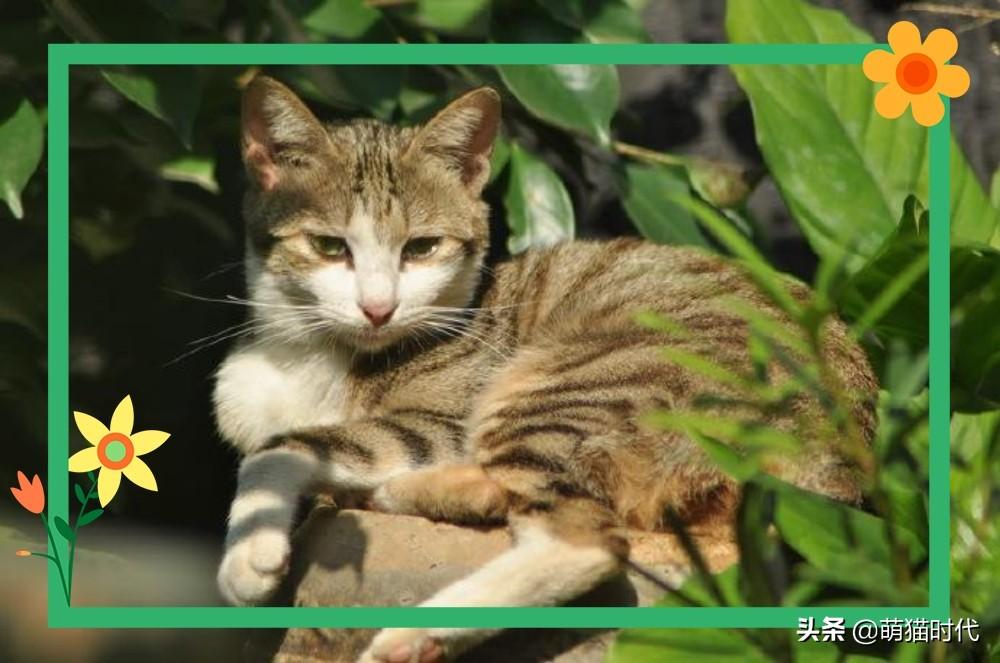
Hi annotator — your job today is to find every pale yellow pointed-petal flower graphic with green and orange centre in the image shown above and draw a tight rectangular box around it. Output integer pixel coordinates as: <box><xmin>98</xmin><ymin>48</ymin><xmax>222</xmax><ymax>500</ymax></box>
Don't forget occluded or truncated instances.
<box><xmin>69</xmin><ymin>396</ymin><xmax>170</xmax><ymax>507</ymax></box>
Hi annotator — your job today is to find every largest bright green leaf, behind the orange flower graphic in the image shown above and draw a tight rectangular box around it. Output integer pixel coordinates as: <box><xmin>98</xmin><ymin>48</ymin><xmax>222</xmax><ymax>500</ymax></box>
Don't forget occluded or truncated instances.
<box><xmin>726</xmin><ymin>0</ymin><xmax>998</xmax><ymax>272</ymax></box>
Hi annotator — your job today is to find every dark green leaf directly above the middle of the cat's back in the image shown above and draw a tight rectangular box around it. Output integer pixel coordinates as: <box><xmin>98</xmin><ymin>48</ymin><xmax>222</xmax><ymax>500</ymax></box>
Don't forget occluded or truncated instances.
<box><xmin>618</xmin><ymin>163</ymin><xmax>709</xmax><ymax>246</ymax></box>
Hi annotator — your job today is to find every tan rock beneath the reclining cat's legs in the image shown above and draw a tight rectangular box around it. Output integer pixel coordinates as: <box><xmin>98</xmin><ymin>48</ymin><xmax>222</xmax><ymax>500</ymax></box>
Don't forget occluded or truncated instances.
<box><xmin>249</xmin><ymin>506</ymin><xmax>736</xmax><ymax>663</ymax></box>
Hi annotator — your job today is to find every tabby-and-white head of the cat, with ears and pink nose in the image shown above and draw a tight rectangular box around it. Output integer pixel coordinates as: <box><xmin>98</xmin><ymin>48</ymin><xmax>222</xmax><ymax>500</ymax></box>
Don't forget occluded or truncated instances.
<box><xmin>242</xmin><ymin>76</ymin><xmax>500</xmax><ymax>351</ymax></box>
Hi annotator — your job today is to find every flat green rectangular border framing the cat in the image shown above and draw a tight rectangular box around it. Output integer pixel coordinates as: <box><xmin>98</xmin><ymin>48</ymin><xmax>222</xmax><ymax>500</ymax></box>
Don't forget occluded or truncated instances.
<box><xmin>48</xmin><ymin>44</ymin><xmax>951</xmax><ymax>628</ymax></box>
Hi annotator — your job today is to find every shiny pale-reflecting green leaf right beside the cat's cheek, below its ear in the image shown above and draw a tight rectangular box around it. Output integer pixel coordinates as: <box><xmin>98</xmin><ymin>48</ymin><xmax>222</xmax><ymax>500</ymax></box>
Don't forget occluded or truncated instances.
<box><xmin>503</xmin><ymin>143</ymin><xmax>575</xmax><ymax>253</ymax></box>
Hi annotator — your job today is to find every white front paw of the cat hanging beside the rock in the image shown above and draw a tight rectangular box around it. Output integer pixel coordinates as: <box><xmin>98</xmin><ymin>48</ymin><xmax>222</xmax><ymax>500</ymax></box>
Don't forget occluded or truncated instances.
<box><xmin>218</xmin><ymin>529</ymin><xmax>291</xmax><ymax>605</ymax></box>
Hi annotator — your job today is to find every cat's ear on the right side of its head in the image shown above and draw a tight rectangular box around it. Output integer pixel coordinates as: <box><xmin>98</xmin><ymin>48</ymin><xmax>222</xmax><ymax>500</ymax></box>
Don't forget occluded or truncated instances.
<box><xmin>407</xmin><ymin>87</ymin><xmax>500</xmax><ymax>195</ymax></box>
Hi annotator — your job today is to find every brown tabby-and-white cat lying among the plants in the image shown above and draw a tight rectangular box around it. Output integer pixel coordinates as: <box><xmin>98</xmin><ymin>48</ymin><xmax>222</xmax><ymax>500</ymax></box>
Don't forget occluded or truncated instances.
<box><xmin>214</xmin><ymin>76</ymin><xmax>877</xmax><ymax>663</ymax></box>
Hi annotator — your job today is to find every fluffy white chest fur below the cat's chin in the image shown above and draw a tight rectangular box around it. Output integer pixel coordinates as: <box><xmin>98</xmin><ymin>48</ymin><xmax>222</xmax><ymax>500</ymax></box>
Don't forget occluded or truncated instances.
<box><xmin>214</xmin><ymin>344</ymin><xmax>349</xmax><ymax>454</ymax></box>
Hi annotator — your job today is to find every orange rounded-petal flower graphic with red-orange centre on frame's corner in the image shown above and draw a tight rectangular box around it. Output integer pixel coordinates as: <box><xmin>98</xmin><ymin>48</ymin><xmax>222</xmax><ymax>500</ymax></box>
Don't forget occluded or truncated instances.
<box><xmin>863</xmin><ymin>21</ymin><xmax>969</xmax><ymax>127</ymax></box>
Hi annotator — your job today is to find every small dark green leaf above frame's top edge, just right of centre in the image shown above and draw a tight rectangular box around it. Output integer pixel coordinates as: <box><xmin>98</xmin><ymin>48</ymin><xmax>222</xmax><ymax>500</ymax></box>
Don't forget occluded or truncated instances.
<box><xmin>537</xmin><ymin>0</ymin><xmax>649</xmax><ymax>44</ymax></box>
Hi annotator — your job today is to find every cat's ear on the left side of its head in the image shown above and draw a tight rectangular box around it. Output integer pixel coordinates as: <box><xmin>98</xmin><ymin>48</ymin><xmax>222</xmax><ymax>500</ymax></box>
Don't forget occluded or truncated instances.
<box><xmin>241</xmin><ymin>76</ymin><xmax>328</xmax><ymax>191</ymax></box>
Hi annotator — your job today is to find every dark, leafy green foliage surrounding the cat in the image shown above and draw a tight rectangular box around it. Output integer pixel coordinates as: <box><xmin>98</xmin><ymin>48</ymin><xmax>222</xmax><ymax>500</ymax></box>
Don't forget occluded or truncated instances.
<box><xmin>0</xmin><ymin>0</ymin><xmax>1000</xmax><ymax>661</ymax></box>
